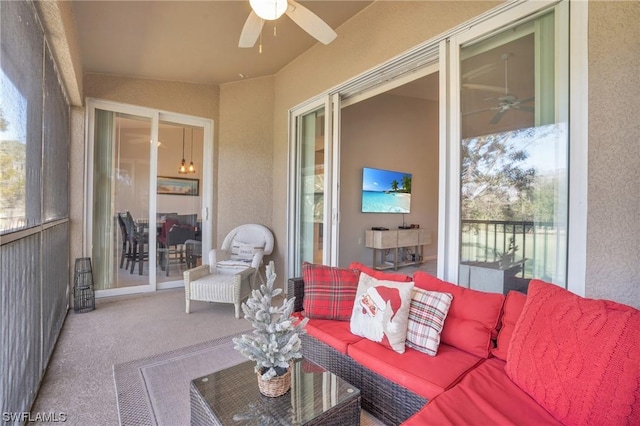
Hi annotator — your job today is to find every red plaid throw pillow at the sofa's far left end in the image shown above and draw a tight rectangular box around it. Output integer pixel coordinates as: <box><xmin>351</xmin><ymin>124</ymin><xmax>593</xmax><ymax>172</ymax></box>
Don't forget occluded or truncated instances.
<box><xmin>302</xmin><ymin>262</ymin><xmax>360</xmax><ymax>321</ymax></box>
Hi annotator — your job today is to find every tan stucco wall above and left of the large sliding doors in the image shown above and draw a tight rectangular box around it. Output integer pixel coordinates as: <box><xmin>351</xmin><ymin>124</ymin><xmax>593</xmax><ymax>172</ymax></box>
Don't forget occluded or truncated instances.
<box><xmin>273</xmin><ymin>1</ymin><xmax>502</xmax><ymax>277</ymax></box>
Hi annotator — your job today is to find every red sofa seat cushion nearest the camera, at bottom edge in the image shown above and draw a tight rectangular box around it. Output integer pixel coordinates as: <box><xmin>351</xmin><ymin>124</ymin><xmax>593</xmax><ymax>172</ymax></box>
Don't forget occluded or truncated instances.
<box><xmin>403</xmin><ymin>355</ymin><xmax>562</xmax><ymax>426</ymax></box>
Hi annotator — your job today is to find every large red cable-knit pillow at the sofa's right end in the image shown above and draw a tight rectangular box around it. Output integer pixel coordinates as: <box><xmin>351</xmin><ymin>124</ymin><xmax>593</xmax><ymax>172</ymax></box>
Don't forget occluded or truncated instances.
<box><xmin>505</xmin><ymin>280</ymin><xmax>640</xmax><ymax>425</ymax></box>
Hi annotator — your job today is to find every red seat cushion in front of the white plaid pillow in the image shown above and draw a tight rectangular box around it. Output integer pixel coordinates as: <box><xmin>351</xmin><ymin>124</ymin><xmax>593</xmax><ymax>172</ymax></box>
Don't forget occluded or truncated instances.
<box><xmin>347</xmin><ymin>339</ymin><xmax>482</xmax><ymax>399</ymax></box>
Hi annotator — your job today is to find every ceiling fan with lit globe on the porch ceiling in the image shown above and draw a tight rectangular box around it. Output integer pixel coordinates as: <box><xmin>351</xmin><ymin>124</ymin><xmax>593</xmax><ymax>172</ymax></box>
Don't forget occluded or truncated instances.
<box><xmin>238</xmin><ymin>0</ymin><xmax>338</xmax><ymax>47</ymax></box>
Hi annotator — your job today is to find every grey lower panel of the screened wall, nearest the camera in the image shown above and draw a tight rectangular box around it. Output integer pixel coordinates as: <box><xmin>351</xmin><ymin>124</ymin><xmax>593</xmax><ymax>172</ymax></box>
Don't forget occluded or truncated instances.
<box><xmin>0</xmin><ymin>234</ymin><xmax>42</xmax><ymax>413</ymax></box>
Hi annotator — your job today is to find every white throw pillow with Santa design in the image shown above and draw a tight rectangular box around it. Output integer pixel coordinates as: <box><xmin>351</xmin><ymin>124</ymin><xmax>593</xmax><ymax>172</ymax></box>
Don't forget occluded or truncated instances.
<box><xmin>350</xmin><ymin>272</ymin><xmax>413</xmax><ymax>353</ymax></box>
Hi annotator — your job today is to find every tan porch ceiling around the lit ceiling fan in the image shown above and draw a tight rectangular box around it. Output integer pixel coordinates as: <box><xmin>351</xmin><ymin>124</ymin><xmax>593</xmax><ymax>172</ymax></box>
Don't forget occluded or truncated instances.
<box><xmin>73</xmin><ymin>0</ymin><xmax>372</xmax><ymax>84</ymax></box>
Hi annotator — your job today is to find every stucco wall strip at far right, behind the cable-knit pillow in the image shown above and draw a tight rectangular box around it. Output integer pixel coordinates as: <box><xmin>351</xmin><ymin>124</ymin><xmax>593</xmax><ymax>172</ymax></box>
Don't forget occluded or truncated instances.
<box><xmin>586</xmin><ymin>1</ymin><xmax>640</xmax><ymax>308</ymax></box>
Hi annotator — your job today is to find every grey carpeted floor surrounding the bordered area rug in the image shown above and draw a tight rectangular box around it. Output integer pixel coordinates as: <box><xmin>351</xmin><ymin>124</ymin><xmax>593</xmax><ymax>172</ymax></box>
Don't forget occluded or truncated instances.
<box><xmin>32</xmin><ymin>289</ymin><xmax>381</xmax><ymax>426</ymax></box>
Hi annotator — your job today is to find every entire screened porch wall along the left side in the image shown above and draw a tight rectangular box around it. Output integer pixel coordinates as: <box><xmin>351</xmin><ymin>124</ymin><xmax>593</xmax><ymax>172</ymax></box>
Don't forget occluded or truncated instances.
<box><xmin>0</xmin><ymin>1</ymin><xmax>70</xmax><ymax>424</ymax></box>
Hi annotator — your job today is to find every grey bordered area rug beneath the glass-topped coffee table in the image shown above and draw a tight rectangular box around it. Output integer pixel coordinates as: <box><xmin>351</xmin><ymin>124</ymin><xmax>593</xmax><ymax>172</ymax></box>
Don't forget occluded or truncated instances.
<box><xmin>113</xmin><ymin>334</ymin><xmax>247</xmax><ymax>426</ymax></box>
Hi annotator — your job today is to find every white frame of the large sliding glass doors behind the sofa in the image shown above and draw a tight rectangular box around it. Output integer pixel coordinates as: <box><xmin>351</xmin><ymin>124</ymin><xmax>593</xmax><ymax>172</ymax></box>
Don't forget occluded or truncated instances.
<box><xmin>286</xmin><ymin>0</ymin><xmax>589</xmax><ymax>296</ymax></box>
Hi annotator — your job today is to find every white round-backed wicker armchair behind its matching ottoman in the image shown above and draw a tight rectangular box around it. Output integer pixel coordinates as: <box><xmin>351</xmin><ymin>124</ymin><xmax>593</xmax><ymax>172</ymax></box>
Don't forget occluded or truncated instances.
<box><xmin>209</xmin><ymin>224</ymin><xmax>273</xmax><ymax>288</ymax></box>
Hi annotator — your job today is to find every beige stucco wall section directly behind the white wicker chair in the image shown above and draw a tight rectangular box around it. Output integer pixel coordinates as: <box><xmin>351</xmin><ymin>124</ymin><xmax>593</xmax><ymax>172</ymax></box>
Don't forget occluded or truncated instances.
<box><xmin>216</xmin><ymin>77</ymin><xmax>279</xmax><ymax>251</ymax></box>
